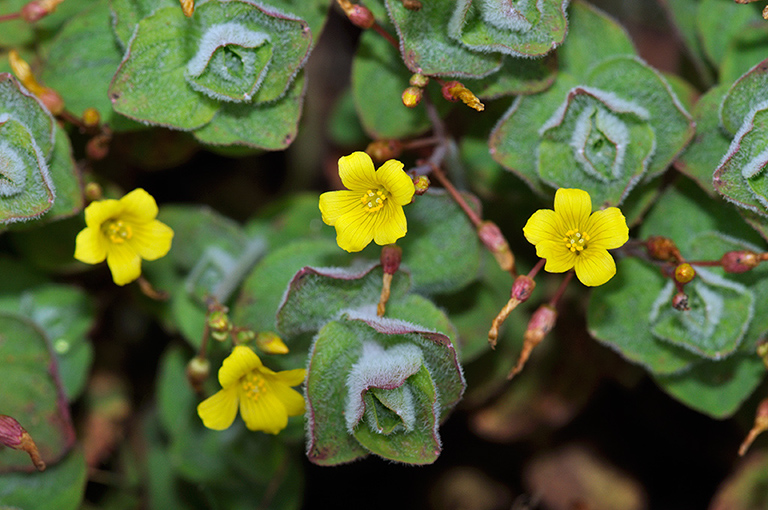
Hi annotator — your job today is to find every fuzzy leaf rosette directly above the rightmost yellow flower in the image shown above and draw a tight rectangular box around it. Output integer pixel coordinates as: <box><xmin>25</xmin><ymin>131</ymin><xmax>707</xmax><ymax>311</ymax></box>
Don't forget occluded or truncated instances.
<box><xmin>490</xmin><ymin>56</ymin><xmax>693</xmax><ymax>205</ymax></box>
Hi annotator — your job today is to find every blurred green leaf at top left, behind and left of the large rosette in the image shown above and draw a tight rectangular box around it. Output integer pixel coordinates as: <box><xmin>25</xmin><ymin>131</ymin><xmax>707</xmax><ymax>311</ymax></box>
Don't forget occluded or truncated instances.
<box><xmin>40</xmin><ymin>0</ymin><xmax>141</xmax><ymax>131</ymax></box>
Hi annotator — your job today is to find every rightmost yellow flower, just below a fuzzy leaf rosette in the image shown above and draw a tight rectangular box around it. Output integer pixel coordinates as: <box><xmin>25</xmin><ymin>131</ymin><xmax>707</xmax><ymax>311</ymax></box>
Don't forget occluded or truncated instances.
<box><xmin>523</xmin><ymin>188</ymin><xmax>629</xmax><ymax>287</ymax></box>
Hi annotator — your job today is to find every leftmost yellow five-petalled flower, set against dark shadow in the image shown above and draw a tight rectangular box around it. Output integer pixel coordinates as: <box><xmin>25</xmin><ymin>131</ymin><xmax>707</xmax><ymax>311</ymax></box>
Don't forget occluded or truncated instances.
<box><xmin>75</xmin><ymin>188</ymin><xmax>173</xmax><ymax>285</ymax></box>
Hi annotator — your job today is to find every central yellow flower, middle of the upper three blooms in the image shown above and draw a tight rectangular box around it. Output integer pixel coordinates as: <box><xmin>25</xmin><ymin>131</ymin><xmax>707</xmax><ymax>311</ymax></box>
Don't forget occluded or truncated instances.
<box><xmin>320</xmin><ymin>152</ymin><xmax>415</xmax><ymax>252</ymax></box>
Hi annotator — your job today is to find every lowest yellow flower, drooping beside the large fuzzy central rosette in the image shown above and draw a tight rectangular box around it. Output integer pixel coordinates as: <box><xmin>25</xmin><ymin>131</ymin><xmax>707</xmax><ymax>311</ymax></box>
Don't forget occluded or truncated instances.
<box><xmin>197</xmin><ymin>345</ymin><xmax>306</xmax><ymax>434</ymax></box>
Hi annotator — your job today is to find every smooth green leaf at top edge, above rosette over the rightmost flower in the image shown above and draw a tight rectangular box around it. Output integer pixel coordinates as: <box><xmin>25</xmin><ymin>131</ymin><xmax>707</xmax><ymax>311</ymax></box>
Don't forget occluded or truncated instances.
<box><xmin>557</xmin><ymin>1</ymin><xmax>637</xmax><ymax>80</ymax></box>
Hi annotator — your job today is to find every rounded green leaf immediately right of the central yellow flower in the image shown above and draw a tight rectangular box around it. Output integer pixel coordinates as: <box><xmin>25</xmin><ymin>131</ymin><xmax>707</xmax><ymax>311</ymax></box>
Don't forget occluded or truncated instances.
<box><xmin>398</xmin><ymin>192</ymin><xmax>481</xmax><ymax>294</ymax></box>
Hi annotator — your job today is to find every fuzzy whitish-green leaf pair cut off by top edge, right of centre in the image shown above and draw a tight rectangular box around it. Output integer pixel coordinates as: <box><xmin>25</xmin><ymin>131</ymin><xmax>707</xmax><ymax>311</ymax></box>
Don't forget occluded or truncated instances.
<box><xmin>446</xmin><ymin>0</ymin><xmax>568</xmax><ymax>57</ymax></box>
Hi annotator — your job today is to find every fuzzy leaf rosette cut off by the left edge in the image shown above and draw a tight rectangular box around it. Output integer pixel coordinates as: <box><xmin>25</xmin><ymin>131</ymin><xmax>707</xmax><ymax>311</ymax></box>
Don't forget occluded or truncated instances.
<box><xmin>0</xmin><ymin>73</ymin><xmax>56</xmax><ymax>223</ymax></box>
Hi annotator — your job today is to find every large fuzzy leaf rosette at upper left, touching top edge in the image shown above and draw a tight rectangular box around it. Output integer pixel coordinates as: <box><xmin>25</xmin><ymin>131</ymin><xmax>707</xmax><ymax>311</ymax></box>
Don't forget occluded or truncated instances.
<box><xmin>109</xmin><ymin>0</ymin><xmax>312</xmax><ymax>150</ymax></box>
